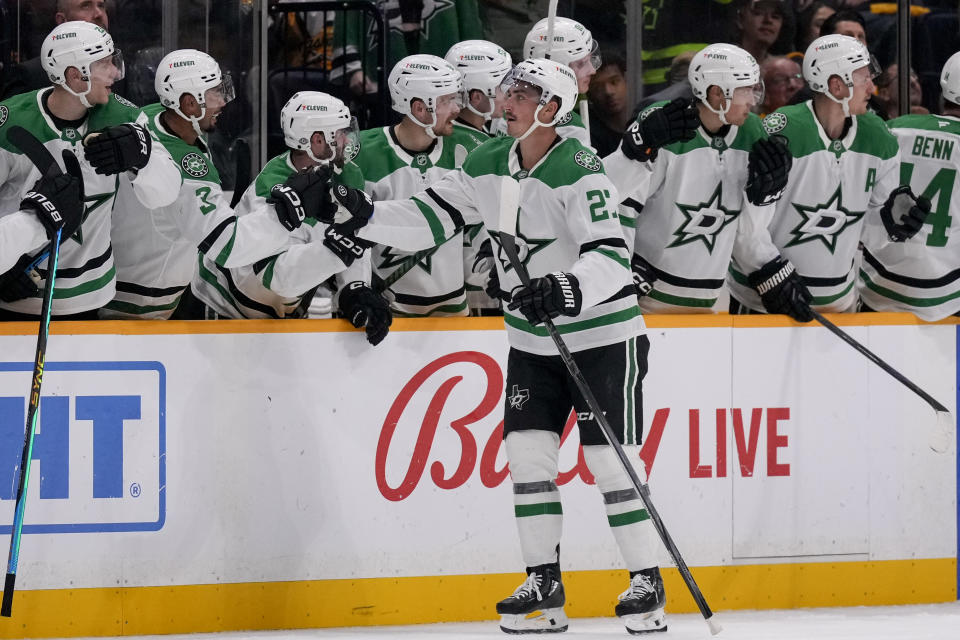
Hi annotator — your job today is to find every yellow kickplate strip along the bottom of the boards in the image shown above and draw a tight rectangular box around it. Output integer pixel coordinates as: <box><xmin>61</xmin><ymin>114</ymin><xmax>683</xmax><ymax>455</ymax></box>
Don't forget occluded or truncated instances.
<box><xmin>0</xmin><ymin>558</ymin><xmax>957</xmax><ymax>638</ymax></box>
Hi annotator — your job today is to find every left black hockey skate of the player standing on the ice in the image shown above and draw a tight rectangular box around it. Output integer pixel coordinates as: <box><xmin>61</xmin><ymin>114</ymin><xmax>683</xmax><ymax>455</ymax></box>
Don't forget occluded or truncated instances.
<box><xmin>497</xmin><ymin>564</ymin><xmax>568</xmax><ymax>633</ymax></box>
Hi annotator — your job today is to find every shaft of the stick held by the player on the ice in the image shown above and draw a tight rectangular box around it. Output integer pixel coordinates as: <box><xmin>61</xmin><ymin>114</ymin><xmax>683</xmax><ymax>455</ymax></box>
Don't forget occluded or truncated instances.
<box><xmin>500</xmin><ymin>231</ymin><xmax>720</xmax><ymax>634</ymax></box>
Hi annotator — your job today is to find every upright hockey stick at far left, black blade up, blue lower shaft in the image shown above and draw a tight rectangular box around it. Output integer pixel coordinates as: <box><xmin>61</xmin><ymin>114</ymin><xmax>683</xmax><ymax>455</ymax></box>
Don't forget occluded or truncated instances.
<box><xmin>0</xmin><ymin>126</ymin><xmax>79</xmax><ymax>618</ymax></box>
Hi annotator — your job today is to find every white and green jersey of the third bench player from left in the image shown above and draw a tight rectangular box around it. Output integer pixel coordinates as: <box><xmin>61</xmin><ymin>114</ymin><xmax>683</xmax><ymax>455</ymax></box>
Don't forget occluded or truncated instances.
<box><xmin>191</xmin><ymin>151</ymin><xmax>370</xmax><ymax>318</ymax></box>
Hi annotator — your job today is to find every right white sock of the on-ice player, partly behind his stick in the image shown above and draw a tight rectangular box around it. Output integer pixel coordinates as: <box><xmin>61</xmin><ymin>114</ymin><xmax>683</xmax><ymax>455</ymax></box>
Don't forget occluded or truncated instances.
<box><xmin>583</xmin><ymin>445</ymin><xmax>658</xmax><ymax>572</ymax></box>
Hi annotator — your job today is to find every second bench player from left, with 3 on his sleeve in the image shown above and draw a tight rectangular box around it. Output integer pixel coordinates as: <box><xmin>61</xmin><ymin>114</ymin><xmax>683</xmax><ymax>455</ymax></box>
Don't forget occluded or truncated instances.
<box><xmin>100</xmin><ymin>49</ymin><xmax>312</xmax><ymax>319</ymax></box>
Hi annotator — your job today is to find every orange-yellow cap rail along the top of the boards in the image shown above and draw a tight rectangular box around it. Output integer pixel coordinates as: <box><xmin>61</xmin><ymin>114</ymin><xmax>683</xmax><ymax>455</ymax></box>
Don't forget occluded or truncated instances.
<box><xmin>0</xmin><ymin>312</ymin><xmax>960</xmax><ymax>336</ymax></box>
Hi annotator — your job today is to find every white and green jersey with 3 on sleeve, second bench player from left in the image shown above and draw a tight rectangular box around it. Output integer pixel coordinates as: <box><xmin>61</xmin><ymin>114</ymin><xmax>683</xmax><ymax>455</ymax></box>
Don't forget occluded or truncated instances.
<box><xmin>100</xmin><ymin>104</ymin><xmax>289</xmax><ymax>319</ymax></box>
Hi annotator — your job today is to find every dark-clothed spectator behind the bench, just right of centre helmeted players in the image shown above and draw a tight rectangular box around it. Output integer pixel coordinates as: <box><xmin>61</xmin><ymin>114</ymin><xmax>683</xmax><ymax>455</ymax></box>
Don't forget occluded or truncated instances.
<box><xmin>589</xmin><ymin>54</ymin><xmax>630</xmax><ymax>156</ymax></box>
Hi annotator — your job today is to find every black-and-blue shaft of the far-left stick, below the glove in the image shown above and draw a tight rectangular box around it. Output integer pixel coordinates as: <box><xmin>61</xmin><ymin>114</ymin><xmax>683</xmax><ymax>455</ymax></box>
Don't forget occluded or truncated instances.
<box><xmin>0</xmin><ymin>229</ymin><xmax>61</xmax><ymax>618</ymax></box>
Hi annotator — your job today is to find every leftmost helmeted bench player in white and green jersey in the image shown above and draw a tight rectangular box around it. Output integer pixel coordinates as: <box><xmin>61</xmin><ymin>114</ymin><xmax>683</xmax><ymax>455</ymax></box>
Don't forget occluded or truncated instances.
<box><xmin>0</xmin><ymin>21</ymin><xmax>177</xmax><ymax>319</ymax></box>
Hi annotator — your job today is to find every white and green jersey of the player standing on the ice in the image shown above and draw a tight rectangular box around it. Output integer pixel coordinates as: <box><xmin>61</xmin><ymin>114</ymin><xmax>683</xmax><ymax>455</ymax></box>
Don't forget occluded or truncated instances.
<box><xmin>359</xmin><ymin>138</ymin><xmax>645</xmax><ymax>355</ymax></box>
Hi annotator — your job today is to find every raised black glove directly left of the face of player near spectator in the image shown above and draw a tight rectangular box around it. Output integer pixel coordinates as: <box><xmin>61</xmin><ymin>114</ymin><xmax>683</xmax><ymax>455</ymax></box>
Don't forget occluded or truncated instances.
<box><xmin>620</xmin><ymin>98</ymin><xmax>700</xmax><ymax>162</ymax></box>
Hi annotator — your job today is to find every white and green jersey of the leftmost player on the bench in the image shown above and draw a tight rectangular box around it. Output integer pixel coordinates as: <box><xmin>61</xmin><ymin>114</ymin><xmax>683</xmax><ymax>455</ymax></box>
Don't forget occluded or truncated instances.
<box><xmin>0</xmin><ymin>88</ymin><xmax>177</xmax><ymax>316</ymax></box>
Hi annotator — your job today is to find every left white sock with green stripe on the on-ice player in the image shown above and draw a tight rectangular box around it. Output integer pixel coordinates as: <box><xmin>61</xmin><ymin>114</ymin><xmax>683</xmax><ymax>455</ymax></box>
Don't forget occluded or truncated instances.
<box><xmin>506</xmin><ymin>429</ymin><xmax>563</xmax><ymax>567</ymax></box>
